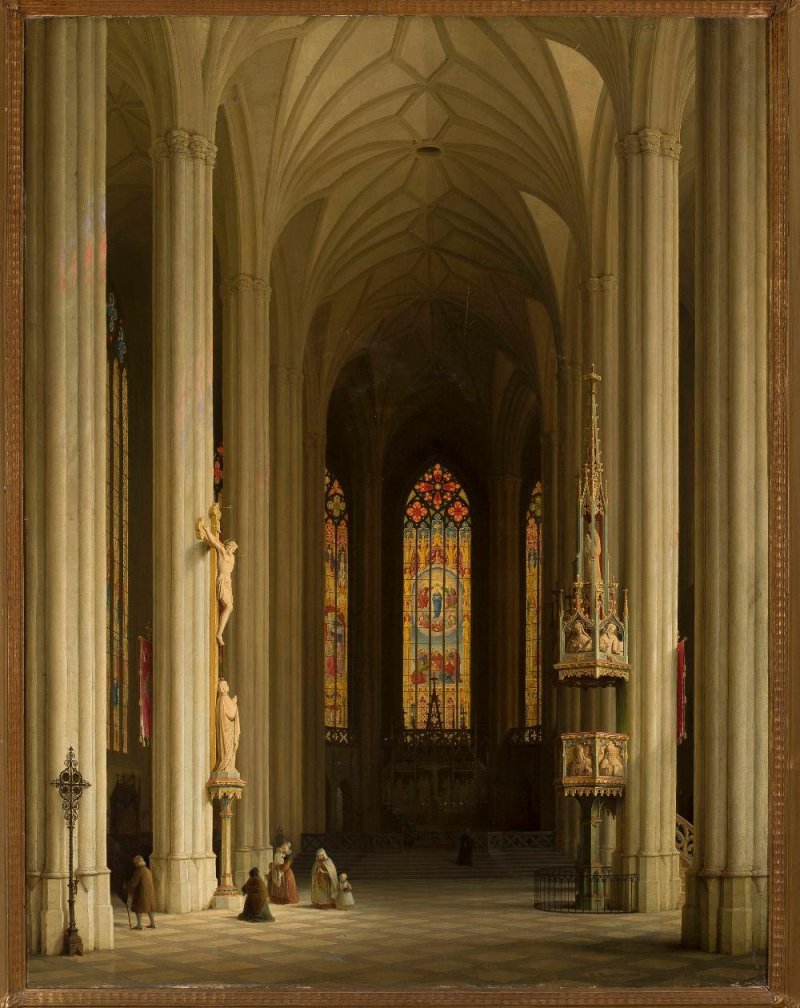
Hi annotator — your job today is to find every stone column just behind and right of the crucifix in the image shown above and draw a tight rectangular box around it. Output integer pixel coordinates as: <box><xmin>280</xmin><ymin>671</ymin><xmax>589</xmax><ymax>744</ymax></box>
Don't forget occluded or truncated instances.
<box><xmin>222</xmin><ymin>273</ymin><xmax>272</xmax><ymax>888</ymax></box>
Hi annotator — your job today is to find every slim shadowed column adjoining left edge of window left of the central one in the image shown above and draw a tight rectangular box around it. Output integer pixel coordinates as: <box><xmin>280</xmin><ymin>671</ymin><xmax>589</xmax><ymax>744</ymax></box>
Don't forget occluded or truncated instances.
<box><xmin>298</xmin><ymin>431</ymin><xmax>326</xmax><ymax>841</ymax></box>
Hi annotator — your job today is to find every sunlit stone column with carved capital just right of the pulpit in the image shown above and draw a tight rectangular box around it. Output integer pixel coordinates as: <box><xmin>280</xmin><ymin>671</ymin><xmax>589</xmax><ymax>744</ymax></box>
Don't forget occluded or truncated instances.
<box><xmin>618</xmin><ymin>123</ymin><xmax>680</xmax><ymax>912</ymax></box>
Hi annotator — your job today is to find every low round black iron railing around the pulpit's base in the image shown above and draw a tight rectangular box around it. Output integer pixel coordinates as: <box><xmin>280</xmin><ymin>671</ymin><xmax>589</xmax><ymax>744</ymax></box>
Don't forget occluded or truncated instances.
<box><xmin>533</xmin><ymin>868</ymin><xmax>639</xmax><ymax>913</ymax></box>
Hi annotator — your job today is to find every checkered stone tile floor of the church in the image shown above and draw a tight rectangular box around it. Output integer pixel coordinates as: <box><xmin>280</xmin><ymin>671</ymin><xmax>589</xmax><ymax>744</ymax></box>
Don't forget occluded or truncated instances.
<box><xmin>28</xmin><ymin>869</ymin><xmax>765</xmax><ymax>991</ymax></box>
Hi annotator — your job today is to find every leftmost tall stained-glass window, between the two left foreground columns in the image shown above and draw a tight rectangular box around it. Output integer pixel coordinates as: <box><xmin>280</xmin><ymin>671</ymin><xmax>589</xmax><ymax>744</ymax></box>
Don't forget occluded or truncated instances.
<box><xmin>106</xmin><ymin>292</ymin><xmax>128</xmax><ymax>752</ymax></box>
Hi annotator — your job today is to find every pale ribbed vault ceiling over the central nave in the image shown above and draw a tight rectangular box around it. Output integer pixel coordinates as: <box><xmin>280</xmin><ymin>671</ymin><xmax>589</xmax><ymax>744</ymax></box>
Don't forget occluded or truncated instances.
<box><xmin>255</xmin><ymin>18</ymin><xmax>602</xmax><ymax>360</ymax></box>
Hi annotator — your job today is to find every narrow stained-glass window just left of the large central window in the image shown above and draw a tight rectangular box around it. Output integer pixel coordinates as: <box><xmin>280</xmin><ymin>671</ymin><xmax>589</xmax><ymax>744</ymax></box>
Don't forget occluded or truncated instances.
<box><xmin>323</xmin><ymin>472</ymin><xmax>350</xmax><ymax>728</ymax></box>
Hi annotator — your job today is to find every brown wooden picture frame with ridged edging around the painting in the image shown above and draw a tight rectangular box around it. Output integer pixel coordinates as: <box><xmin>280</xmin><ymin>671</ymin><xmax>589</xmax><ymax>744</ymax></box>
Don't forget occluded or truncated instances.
<box><xmin>0</xmin><ymin>0</ymin><xmax>789</xmax><ymax>1008</ymax></box>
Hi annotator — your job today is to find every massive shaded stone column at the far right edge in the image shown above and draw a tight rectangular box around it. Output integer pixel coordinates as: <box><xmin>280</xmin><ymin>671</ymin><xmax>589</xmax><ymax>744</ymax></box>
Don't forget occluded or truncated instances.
<box><xmin>683</xmin><ymin>21</ymin><xmax>769</xmax><ymax>955</ymax></box>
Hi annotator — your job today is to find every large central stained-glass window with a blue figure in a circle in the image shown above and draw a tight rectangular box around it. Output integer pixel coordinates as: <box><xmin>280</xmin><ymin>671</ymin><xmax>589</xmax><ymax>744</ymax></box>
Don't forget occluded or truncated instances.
<box><xmin>403</xmin><ymin>463</ymin><xmax>473</xmax><ymax>730</ymax></box>
